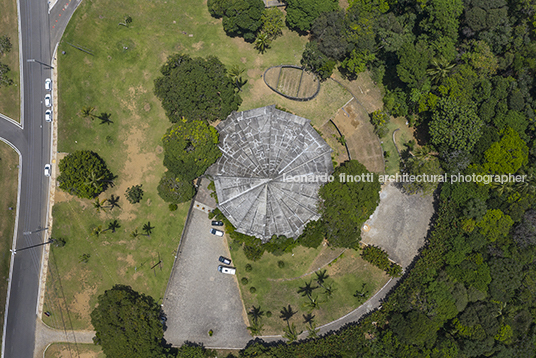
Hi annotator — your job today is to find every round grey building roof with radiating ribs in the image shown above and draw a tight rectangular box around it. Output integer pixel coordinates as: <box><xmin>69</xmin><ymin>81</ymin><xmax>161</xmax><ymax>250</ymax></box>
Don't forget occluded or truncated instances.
<box><xmin>207</xmin><ymin>106</ymin><xmax>333</xmax><ymax>242</ymax></box>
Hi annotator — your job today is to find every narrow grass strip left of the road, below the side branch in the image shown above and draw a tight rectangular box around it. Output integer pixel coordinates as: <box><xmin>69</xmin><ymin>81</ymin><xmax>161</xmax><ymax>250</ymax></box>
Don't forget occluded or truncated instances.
<box><xmin>0</xmin><ymin>142</ymin><xmax>19</xmax><ymax>341</ymax></box>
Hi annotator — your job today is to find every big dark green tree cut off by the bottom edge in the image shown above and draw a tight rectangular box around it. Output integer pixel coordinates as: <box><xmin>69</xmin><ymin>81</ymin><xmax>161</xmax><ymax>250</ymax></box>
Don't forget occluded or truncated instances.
<box><xmin>91</xmin><ymin>285</ymin><xmax>164</xmax><ymax>358</ymax></box>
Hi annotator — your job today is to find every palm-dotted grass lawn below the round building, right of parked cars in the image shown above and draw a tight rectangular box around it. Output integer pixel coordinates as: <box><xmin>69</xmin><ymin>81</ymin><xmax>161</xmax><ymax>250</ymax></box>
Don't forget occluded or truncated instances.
<box><xmin>231</xmin><ymin>246</ymin><xmax>389</xmax><ymax>335</ymax></box>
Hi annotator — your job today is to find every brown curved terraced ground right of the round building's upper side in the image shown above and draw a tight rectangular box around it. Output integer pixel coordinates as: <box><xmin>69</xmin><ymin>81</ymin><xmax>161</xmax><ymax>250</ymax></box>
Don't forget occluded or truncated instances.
<box><xmin>333</xmin><ymin>99</ymin><xmax>385</xmax><ymax>173</ymax></box>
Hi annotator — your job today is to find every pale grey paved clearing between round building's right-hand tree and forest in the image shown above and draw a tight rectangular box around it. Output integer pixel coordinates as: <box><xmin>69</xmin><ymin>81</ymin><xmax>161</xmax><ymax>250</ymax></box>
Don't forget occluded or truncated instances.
<box><xmin>361</xmin><ymin>183</ymin><xmax>434</xmax><ymax>267</ymax></box>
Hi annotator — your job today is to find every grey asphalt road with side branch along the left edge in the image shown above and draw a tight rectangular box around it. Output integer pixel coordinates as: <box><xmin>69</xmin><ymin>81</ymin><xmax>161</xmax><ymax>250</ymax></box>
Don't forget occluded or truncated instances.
<box><xmin>0</xmin><ymin>0</ymin><xmax>79</xmax><ymax>358</ymax></box>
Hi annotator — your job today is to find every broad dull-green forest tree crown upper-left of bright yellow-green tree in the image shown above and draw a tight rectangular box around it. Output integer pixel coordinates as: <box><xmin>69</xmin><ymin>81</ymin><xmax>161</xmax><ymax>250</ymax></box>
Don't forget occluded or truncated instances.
<box><xmin>429</xmin><ymin>98</ymin><xmax>484</xmax><ymax>153</ymax></box>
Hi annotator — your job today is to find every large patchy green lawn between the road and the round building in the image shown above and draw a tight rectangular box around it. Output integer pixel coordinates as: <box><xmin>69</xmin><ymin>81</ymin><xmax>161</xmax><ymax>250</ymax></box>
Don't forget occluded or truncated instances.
<box><xmin>45</xmin><ymin>0</ymin><xmax>378</xmax><ymax>329</ymax></box>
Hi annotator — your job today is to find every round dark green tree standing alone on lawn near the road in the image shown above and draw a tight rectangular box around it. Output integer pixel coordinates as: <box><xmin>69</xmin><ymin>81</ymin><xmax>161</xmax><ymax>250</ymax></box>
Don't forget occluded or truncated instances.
<box><xmin>58</xmin><ymin>150</ymin><xmax>114</xmax><ymax>199</ymax></box>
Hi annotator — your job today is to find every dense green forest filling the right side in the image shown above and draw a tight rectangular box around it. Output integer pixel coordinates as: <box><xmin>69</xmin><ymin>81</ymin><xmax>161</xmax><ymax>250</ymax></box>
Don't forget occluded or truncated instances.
<box><xmin>228</xmin><ymin>0</ymin><xmax>536</xmax><ymax>358</ymax></box>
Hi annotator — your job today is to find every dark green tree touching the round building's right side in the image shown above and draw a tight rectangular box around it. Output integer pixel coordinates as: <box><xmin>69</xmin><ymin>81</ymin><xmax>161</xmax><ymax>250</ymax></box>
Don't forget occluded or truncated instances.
<box><xmin>319</xmin><ymin>160</ymin><xmax>380</xmax><ymax>247</ymax></box>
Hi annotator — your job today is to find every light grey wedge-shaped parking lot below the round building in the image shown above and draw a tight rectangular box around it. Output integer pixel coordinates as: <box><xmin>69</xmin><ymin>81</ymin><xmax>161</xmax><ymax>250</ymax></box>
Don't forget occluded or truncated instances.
<box><xmin>163</xmin><ymin>208</ymin><xmax>252</xmax><ymax>348</ymax></box>
